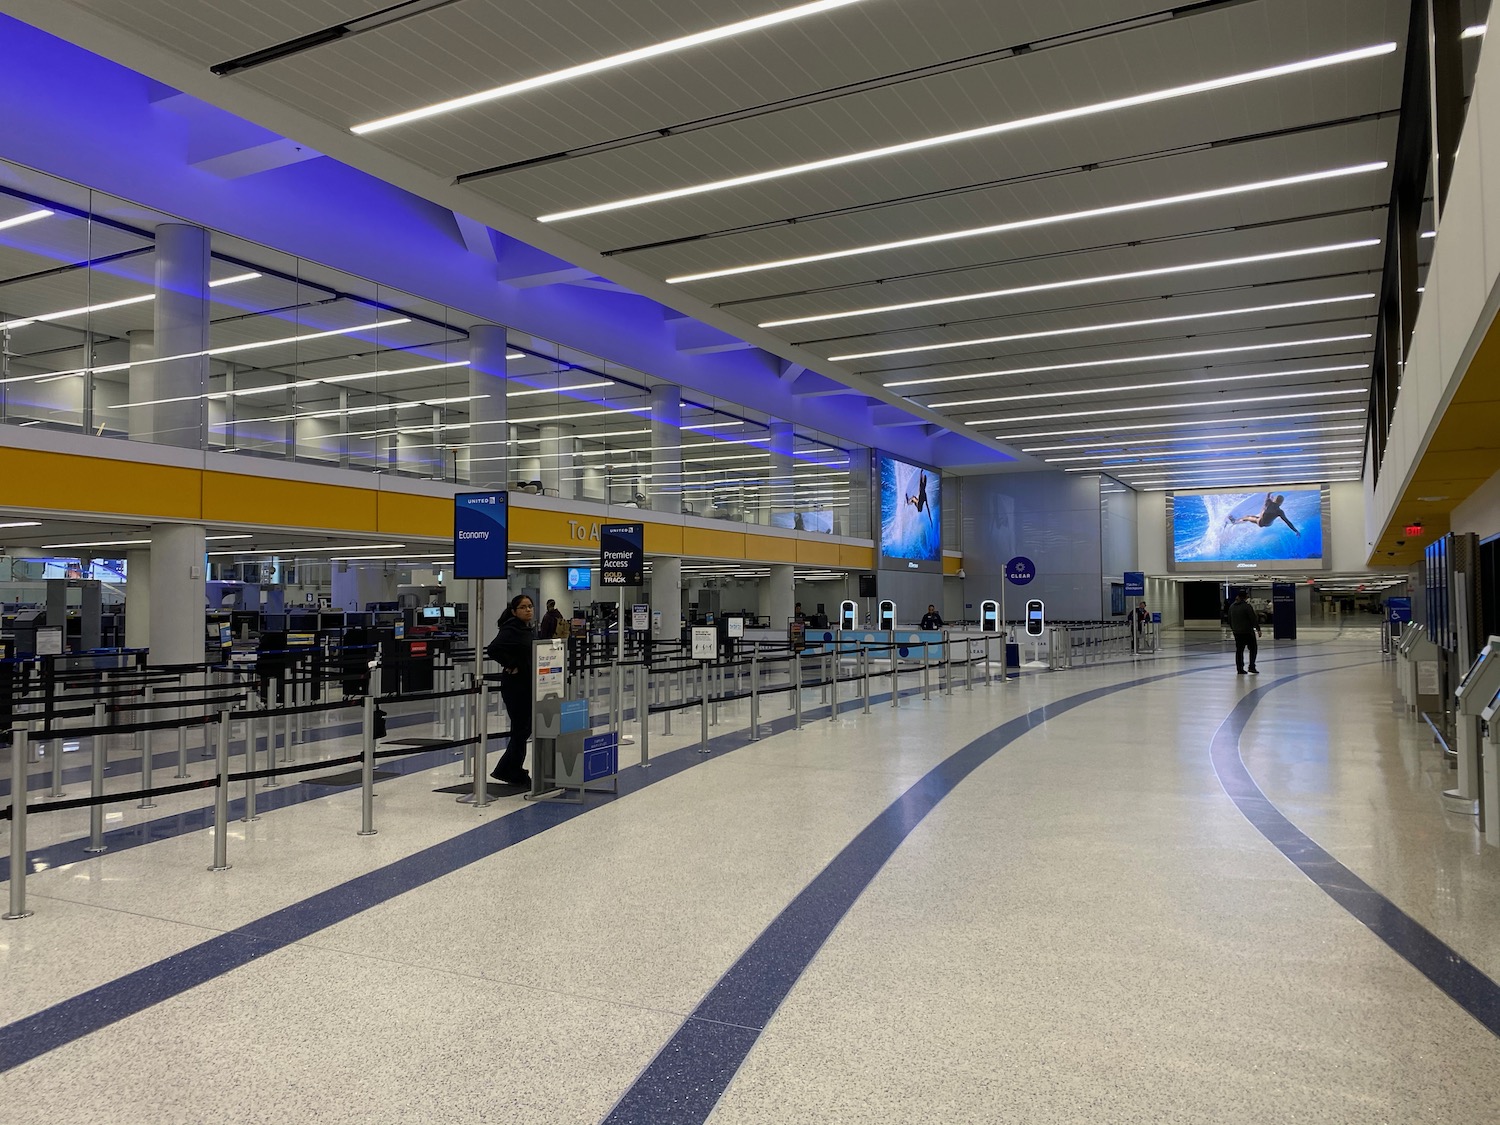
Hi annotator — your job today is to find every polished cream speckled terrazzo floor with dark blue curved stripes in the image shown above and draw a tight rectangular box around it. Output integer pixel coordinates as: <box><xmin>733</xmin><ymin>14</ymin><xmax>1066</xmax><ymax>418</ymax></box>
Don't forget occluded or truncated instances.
<box><xmin>0</xmin><ymin>630</ymin><xmax>1500</xmax><ymax>1125</ymax></box>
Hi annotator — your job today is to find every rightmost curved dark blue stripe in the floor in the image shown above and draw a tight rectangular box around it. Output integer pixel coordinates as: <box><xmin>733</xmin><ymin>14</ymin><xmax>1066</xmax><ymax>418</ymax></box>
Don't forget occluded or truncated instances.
<box><xmin>1211</xmin><ymin>672</ymin><xmax>1500</xmax><ymax>1035</ymax></box>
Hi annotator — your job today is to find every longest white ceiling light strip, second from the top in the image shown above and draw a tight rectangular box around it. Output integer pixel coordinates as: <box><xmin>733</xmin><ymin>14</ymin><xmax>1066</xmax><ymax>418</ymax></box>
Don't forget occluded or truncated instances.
<box><xmin>537</xmin><ymin>42</ymin><xmax>1397</xmax><ymax>222</ymax></box>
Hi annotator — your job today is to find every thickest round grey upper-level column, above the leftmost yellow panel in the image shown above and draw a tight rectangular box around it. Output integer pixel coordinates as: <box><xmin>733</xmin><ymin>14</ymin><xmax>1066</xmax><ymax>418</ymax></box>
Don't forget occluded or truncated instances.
<box><xmin>146</xmin><ymin>224</ymin><xmax>210</xmax><ymax>450</ymax></box>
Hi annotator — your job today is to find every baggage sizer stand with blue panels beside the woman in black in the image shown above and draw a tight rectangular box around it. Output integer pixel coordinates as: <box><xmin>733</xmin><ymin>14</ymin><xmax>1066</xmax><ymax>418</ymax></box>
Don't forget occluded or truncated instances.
<box><xmin>527</xmin><ymin>638</ymin><xmax>620</xmax><ymax>804</ymax></box>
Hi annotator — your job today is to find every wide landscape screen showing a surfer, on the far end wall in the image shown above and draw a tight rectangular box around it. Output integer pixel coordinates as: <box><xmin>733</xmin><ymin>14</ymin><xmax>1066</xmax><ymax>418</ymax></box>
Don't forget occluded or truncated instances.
<box><xmin>1167</xmin><ymin>488</ymin><xmax>1323</xmax><ymax>569</ymax></box>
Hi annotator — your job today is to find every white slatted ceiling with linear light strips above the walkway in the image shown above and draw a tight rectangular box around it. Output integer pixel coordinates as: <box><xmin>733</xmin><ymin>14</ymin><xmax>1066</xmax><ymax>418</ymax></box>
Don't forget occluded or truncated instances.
<box><xmin>14</xmin><ymin>0</ymin><xmax>1404</xmax><ymax>482</ymax></box>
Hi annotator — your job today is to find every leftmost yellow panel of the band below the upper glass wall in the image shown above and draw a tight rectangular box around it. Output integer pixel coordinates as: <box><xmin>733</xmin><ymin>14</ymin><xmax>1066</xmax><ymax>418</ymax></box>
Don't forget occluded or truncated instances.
<box><xmin>0</xmin><ymin>449</ymin><xmax>203</xmax><ymax>519</ymax></box>
